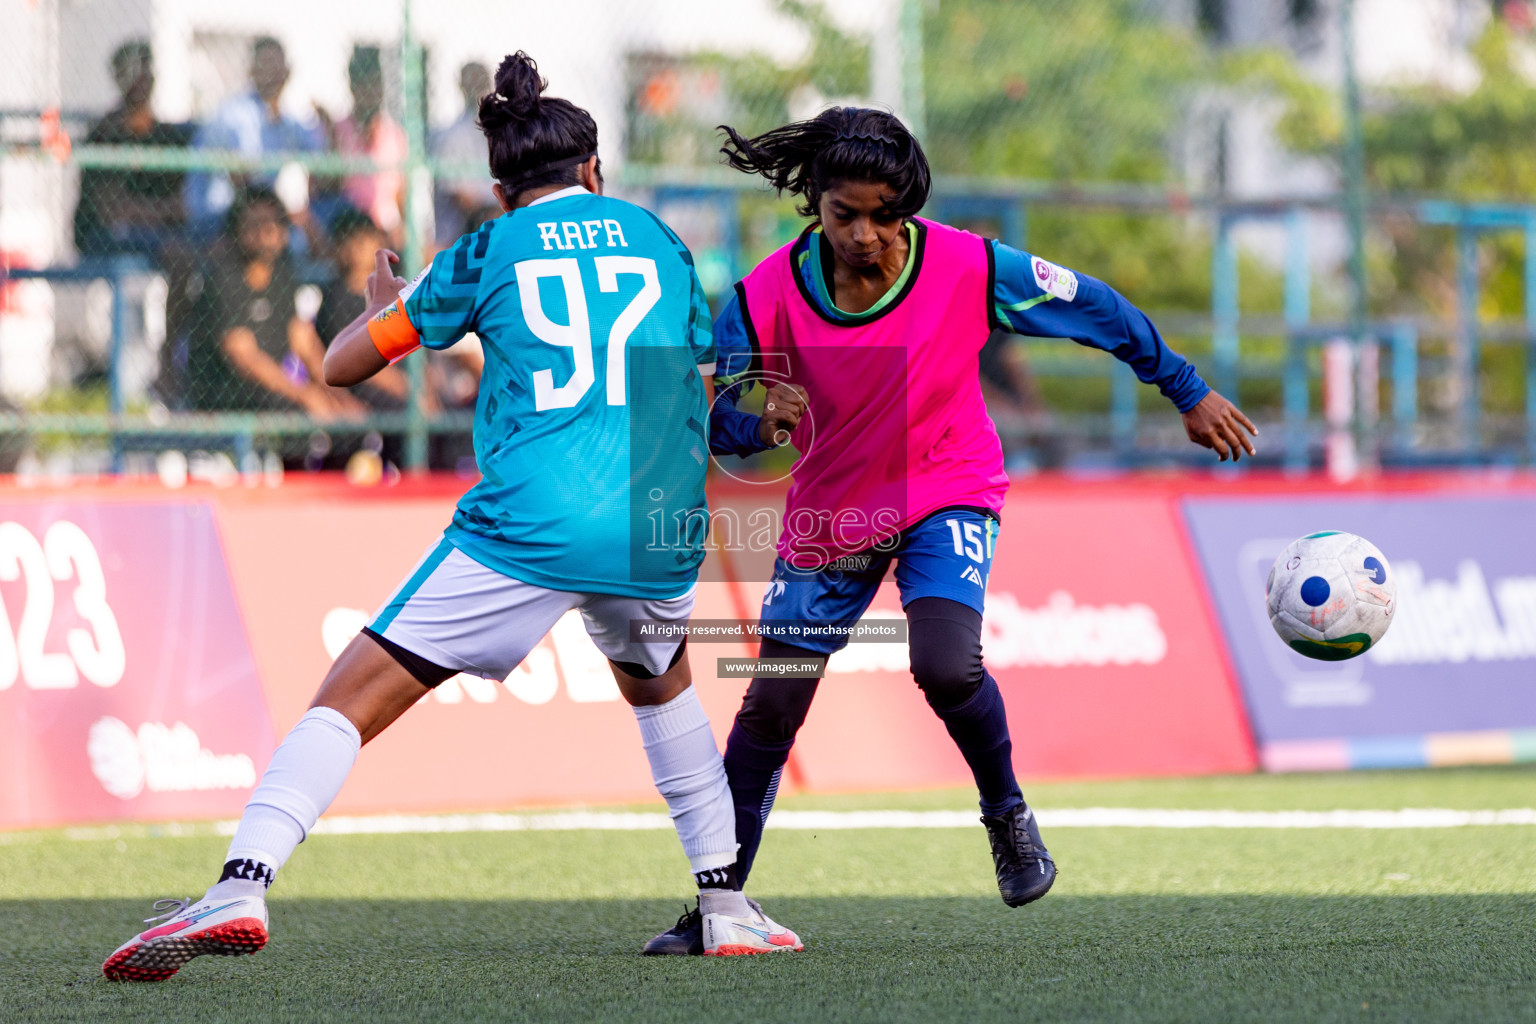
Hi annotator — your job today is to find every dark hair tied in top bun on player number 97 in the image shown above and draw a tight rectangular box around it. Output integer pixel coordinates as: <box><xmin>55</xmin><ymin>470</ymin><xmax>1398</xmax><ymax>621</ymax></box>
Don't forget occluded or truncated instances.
<box><xmin>479</xmin><ymin>49</ymin><xmax>598</xmax><ymax>201</ymax></box>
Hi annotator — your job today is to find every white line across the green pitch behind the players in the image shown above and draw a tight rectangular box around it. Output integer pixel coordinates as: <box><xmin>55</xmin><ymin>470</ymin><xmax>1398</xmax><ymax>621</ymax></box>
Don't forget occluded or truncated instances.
<box><xmin>14</xmin><ymin>808</ymin><xmax>1536</xmax><ymax>846</ymax></box>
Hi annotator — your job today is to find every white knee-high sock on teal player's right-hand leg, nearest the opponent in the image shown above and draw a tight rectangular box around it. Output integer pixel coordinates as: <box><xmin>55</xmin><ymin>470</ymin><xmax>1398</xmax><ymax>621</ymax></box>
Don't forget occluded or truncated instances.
<box><xmin>634</xmin><ymin>686</ymin><xmax>736</xmax><ymax>872</ymax></box>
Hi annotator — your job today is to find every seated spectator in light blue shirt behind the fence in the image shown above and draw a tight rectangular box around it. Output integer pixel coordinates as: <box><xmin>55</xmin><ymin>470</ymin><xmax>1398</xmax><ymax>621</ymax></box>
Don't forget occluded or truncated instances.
<box><xmin>186</xmin><ymin>35</ymin><xmax>324</xmax><ymax>246</ymax></box>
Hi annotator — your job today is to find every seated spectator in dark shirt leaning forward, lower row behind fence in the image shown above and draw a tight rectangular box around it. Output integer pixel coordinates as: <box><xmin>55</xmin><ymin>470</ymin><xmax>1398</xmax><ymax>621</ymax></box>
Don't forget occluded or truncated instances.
<box><xmin>187</xmin><ymin>186</ymin><xmax>362</xmax><ymax>421</ymax></box>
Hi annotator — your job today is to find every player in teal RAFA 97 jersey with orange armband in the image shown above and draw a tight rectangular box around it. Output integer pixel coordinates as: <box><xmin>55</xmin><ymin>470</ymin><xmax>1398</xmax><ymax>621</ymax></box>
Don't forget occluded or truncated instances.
<box><xmin>103</xmin><ymin>52</ymin><xmax>800</xmax><ymax>981</ymax></box>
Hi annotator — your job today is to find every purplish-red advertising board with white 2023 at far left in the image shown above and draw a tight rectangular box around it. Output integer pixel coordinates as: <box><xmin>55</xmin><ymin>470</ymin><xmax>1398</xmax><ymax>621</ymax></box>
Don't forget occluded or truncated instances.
<box><xmin>0</xmin><ymin>491</ymin><xmax>273</xmax><ymax>827</ymax></box>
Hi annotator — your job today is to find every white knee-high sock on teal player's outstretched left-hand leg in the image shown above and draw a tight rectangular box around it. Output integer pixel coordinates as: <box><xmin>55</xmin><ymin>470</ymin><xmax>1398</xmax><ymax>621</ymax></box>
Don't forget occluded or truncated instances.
<box><xmin>209</xmin><ymin>708</ymin><xmax>362</xmax><ymax>898</ymax></box>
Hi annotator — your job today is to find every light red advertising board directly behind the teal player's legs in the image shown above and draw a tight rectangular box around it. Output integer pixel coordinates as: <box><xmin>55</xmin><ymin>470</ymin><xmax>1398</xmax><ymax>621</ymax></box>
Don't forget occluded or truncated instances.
<box><xmin>211</xmin><ymin>484</ymin><xmax>755</xmax><ymax>814</ymax></box>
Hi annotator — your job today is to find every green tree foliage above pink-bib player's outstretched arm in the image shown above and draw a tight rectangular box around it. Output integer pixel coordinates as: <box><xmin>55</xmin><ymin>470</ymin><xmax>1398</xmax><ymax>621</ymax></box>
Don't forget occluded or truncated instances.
<box><xmin>923</xmin><ymin>0</ymin><xmax>1283</xmax><ymax>310</ymax></box>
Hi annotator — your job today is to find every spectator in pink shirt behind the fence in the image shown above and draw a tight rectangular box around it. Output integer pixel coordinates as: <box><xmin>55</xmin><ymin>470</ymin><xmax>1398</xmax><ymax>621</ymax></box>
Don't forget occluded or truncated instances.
<box><xmin>321</xmin><ymin>46</ymin><xmax>407</xmax><ymax>247</ymax></box>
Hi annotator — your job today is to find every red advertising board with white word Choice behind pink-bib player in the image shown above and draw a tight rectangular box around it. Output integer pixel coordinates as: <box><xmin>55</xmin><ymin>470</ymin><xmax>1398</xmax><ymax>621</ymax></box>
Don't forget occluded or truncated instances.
<box><xmin>792</xmin><ymin>485</ymin><xmax>1255</xmax><ymax>789</ymax></box>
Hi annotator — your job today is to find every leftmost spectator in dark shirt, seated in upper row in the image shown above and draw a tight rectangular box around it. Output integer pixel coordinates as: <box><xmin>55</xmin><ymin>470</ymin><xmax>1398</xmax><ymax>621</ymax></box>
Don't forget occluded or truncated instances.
<box><xmin>75</xmin><ymin>40</ymin><xmax>192</xmax><ymax>261</ymax></box>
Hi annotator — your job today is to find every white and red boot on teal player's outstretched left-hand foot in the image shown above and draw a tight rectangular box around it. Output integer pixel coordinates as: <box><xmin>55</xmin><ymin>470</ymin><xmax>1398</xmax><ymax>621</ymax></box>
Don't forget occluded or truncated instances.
<box><xmin>101</xmin><ymin>897</ymin><xmax>267</xmax><ymax>981</ymax></box>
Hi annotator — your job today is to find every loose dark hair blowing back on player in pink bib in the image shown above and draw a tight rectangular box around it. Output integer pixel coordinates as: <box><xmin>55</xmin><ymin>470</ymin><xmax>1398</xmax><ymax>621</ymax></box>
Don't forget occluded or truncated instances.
<box><xmin>719</xmin><ymin>106</ymin><xmax>932</xmax><ymax>216</ymax></box>
